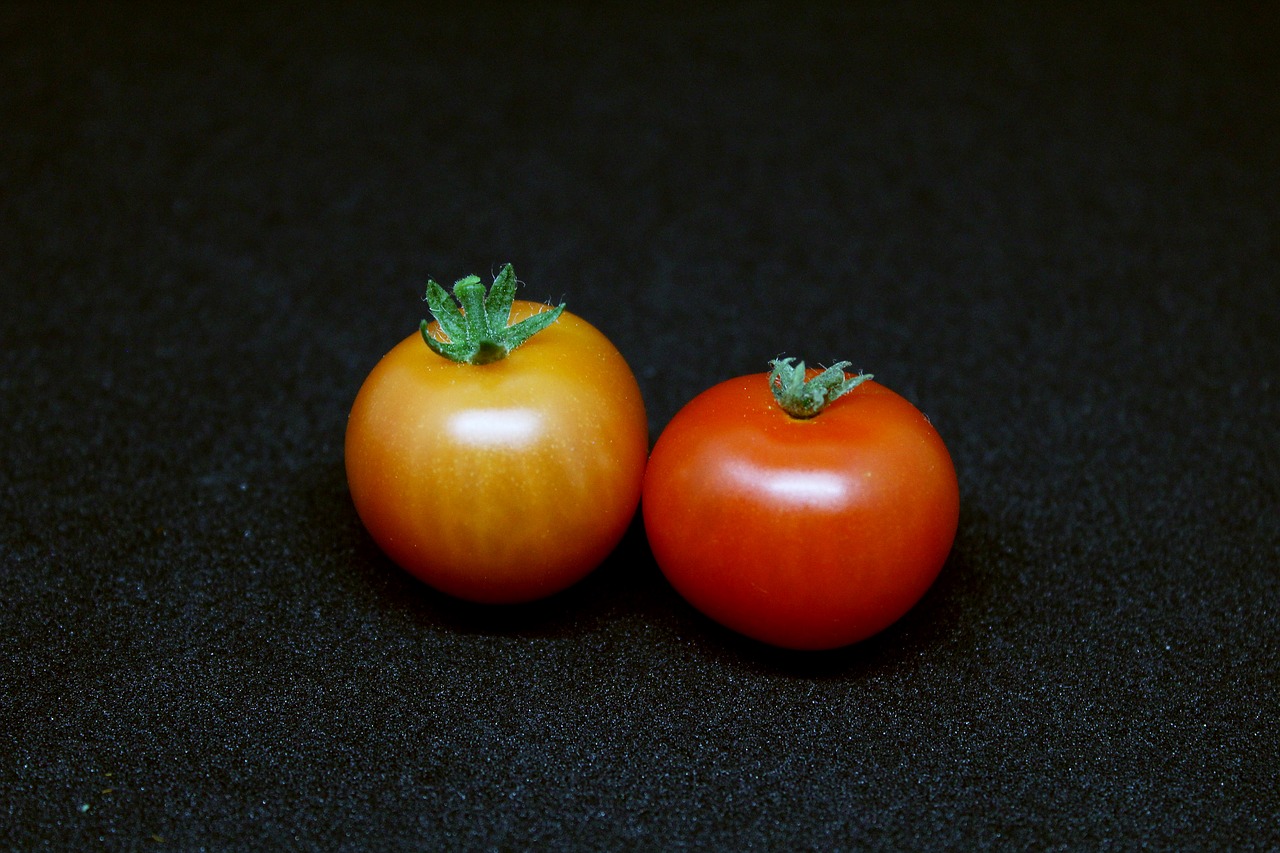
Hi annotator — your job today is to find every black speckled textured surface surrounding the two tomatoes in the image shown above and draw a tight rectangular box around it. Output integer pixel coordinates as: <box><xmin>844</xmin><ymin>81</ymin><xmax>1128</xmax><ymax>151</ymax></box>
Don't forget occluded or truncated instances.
<box><xmin>0</xmin><ymin>3</ymin><xmax>1280</xmax><ymax>849</ymax></box>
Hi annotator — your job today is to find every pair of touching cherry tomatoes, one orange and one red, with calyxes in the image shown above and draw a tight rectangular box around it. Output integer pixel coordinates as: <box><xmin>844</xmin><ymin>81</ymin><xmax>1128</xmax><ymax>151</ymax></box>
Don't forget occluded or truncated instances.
<box><xmin>346</xmin><ymin>265</ymin><xmax>959</xmax><ymax>649</ymax></box>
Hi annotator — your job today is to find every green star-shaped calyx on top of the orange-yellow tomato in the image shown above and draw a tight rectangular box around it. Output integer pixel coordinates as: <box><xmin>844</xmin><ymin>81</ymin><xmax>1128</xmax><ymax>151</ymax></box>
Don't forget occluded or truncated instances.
<box><xmin>419</xmin><ymin>264</ymin><xmax>564</xmax><ymax>365</ymax></box>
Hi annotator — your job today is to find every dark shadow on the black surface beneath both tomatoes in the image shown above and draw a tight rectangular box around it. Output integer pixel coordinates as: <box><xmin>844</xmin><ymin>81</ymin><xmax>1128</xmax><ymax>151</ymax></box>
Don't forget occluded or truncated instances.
<box><xmin>326</xmin><ymin>448</ymin><xmax>1014</xmax><ymax>660</ymax></box>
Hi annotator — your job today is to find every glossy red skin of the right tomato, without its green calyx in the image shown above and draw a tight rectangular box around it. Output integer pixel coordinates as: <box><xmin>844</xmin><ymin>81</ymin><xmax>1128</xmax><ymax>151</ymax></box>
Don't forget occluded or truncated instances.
<box><xmin>641</xmin><ymin>371</ymin><xmax>960</xmax><ymax>649</ymax></box>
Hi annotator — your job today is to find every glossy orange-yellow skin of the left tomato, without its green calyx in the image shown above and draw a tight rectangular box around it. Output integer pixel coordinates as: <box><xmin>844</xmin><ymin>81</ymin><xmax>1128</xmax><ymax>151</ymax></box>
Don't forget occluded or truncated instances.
<box><xmin>344</xmin><ymin>300</ymin><xmax>649</xmax><ymax>603</ymax></box>
